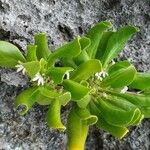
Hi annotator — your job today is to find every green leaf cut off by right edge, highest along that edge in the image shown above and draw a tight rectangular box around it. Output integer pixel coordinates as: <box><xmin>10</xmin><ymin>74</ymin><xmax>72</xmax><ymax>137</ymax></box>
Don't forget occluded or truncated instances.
<box><xmin>129</xmin><ymin>72</ymin><xmax>150</xmax><ymax>90</ymax></box>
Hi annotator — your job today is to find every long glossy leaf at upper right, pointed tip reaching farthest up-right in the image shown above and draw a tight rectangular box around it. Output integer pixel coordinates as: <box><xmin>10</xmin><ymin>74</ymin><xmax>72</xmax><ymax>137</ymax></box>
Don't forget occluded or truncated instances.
<box><xmin>102</xmin><ymin>26</ymin><xmax>139</xmax><ymax>68</ymax></box>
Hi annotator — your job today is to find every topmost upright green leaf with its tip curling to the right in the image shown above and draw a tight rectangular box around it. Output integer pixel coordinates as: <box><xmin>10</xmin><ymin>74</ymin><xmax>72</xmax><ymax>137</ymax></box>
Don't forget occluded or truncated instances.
<box><xmin>86</xmin><ymin>21</ymin><xmax>112</xmax><ymax>58</ymax></box>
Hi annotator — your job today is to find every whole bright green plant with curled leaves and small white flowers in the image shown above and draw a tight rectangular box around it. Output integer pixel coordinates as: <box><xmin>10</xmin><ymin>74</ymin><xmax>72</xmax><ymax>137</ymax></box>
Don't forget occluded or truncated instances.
<box><xmin>0</xmin><ymin>21</ymin><xmax>150</xmax><ymax>150</ymax></box>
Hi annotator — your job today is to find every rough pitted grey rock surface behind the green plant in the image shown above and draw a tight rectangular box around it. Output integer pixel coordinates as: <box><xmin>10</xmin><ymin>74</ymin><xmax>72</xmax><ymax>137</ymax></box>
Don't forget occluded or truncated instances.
<box><xmin>0</xmin><ymin>0</ymin><xmax>150</xmax><ymax>150</ymax></box>
